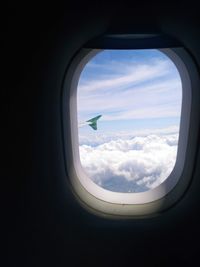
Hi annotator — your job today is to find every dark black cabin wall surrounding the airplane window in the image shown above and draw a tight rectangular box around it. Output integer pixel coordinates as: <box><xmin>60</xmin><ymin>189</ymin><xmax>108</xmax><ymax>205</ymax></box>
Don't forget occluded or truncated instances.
<box><xmin>1</xmin><ymin>2</ymin><xmax>200</xmax><ymax>266</ymax></box>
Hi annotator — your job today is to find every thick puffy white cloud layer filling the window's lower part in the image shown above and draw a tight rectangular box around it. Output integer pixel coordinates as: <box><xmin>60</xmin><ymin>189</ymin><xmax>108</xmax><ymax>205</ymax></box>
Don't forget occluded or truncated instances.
<box><xmin>80</xmin><ymin>133</ymin><xmax>178</xmax><ymax>192</ymax></box>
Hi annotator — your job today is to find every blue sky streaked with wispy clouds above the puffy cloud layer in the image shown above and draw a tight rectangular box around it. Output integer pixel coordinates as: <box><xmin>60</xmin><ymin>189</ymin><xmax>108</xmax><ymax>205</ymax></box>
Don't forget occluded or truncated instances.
<box><xmin>77</xmin><ymin>49</ymin><xmax>182</xmax><ymax>134</ymax></box>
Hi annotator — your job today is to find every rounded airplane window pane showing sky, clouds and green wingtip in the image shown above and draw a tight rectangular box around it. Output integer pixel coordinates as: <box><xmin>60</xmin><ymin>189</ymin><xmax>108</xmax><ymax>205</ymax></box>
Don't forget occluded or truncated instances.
<box><xmin>77</xmin><ymin>49</ymin><xmax>182</xmax><ymax>193</ymax></box>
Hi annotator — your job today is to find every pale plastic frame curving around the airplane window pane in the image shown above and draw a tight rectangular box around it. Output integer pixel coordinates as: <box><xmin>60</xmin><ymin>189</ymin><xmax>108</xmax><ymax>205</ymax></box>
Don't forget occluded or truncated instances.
<box><xmin>62</xmin><ymin>47</ymin><xmax>200</xmax><ymax>218</ymax></box>
